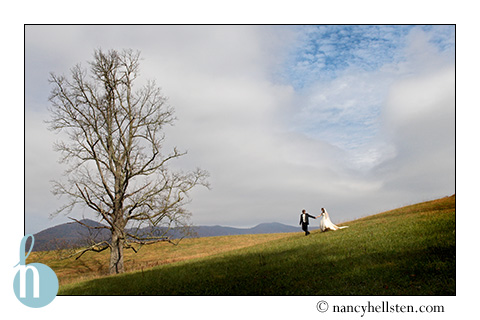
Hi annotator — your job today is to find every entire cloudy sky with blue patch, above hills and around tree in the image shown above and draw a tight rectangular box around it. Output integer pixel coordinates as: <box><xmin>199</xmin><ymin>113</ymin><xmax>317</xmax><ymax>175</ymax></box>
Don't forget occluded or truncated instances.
<box><xmin>25</xmin><ymin>25</ymin><xmax>456</xmax><ymax>233</ymax></box>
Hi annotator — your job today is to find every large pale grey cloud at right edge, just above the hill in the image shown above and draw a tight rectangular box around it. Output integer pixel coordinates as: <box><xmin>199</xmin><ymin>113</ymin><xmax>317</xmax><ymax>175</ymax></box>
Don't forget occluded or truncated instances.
<box><xmin>380</xmin><ymin>66</ymin><xmax>455</xmax><ymax>197</ymax></box>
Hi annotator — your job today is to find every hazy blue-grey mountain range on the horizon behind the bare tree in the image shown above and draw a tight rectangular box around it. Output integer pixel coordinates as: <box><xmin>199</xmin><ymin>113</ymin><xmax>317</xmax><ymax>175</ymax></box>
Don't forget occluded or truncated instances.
<box><xmin>31</xmin><ymin>219</ymin><xmax>300</xmax><ymax>251</ymax></box>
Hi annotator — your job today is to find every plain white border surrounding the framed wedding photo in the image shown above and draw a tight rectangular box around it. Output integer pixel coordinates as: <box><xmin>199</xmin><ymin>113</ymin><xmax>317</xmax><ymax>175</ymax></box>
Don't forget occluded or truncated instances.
<box><xmin>0</xmin><ymin>0</ymin><xmax>480</xmax><ymax>319</ymax></box>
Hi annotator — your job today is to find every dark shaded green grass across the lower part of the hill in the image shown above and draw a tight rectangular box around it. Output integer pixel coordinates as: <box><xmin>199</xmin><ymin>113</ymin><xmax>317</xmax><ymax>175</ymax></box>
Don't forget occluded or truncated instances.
<box><xmin>63</xmin><ymin>234</ymin><xmax>455</xmax><ymax>296</ymax></box>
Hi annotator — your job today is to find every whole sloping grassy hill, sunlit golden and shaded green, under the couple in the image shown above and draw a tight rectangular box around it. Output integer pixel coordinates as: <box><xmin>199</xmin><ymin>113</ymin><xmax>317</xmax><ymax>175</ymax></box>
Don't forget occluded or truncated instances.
<box><xmin>30</xmin><ymin>196</ymin><xmax>456</xmax><ymax>295</ymax></box>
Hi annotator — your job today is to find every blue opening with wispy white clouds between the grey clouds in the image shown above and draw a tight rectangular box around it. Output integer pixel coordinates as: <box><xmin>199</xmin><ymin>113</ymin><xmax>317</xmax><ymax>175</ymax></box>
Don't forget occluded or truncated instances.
<box><xmin>280</xmin><ymin>25</ymin><xmax>455</xmax><ymax>170</ymax></box>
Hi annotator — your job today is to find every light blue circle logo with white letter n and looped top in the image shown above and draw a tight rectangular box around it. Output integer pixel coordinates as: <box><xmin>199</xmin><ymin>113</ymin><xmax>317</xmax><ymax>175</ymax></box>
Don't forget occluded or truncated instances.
<box><xmin>13</xmin><ymin>234</ymin><xmax>58</xmax><ymax>308</ymax></box>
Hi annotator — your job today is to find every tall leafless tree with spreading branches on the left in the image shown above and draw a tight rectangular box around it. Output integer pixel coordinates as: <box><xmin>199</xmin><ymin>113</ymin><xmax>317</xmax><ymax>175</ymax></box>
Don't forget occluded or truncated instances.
<box><xmin>49</xmin><ymin>50</ymin><xmax>208</xmax><ymax>274</ymax></box>
